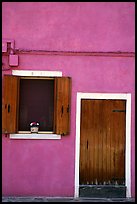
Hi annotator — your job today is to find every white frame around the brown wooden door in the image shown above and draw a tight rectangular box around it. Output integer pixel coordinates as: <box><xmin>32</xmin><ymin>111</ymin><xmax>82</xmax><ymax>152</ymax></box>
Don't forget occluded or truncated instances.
<box><xmin>74</xmin><ymin>92</ymin><xmax>131</xmax><ymax>198</ymax></box>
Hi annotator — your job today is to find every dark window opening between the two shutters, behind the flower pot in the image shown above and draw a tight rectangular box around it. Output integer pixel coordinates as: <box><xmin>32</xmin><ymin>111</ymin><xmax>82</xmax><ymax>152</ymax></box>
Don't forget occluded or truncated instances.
<box><xmin>19</xmin><ymin>79</ymin><xmax>54</xmax><ymax>131</ymax></box>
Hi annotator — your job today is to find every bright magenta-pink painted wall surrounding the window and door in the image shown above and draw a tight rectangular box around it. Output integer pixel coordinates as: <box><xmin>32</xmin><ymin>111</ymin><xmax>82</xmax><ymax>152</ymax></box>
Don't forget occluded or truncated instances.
<box><xmin>2</xmin><ymin>2</ymin><xmax>135</xmax><ymax>197</ymax></box>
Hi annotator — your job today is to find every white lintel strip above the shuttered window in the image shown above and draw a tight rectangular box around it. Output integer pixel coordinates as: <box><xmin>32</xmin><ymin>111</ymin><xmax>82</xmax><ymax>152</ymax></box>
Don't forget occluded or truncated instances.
<box><xmin>12</xmin><ymin>70</ymin><xmax>62</xmax><ymax>77</ymax></box>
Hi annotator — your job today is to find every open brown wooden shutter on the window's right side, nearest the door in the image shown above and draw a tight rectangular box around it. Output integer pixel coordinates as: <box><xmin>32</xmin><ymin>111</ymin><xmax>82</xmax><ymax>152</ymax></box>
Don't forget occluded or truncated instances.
<box><xmin>54</xmin><ymin>77</ymin><xmax>71</xmax><ymax>135</ymax></box>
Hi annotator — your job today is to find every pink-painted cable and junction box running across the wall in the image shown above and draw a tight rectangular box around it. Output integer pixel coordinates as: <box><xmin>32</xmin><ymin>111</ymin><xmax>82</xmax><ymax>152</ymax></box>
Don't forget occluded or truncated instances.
<box><xmin>2</xmin><ymin>40</ymin><xmax>135</xmax><ymax>71</ymax></box>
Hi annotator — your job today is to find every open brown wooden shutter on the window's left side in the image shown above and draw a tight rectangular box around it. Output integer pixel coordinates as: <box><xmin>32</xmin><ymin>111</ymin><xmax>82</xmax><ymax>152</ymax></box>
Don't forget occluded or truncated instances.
<box><xmin>2</xmin><ymin>75</ymin><xmax>19</xmax><ymax>133</ymax></box>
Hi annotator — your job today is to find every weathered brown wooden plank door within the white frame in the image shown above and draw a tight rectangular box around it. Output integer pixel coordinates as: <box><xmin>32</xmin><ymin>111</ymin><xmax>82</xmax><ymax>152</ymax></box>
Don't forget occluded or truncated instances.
<box><xmin>80</xmin><ymin>99</ymin><xmax>126</xmax><ymax>185</ymax></box>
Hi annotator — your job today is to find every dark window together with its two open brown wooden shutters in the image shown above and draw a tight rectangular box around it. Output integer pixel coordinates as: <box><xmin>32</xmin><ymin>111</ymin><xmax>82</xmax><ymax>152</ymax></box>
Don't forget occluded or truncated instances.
<box><xmin>2</xmin><ymin>75</ymin><xmax>71</xmax><ymax>135</ymax></box>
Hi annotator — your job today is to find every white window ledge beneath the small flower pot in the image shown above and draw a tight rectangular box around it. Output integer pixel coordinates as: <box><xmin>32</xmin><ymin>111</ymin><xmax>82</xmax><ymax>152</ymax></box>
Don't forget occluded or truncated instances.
<box><xmin>10</xmin><ymin>133</ymin><xmax>61</xmax><ymax>140</ymax></box>
